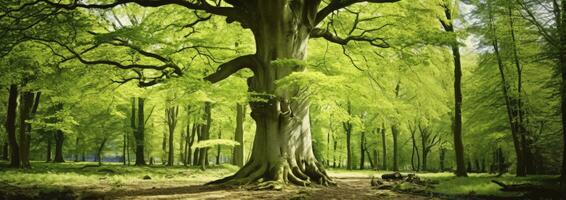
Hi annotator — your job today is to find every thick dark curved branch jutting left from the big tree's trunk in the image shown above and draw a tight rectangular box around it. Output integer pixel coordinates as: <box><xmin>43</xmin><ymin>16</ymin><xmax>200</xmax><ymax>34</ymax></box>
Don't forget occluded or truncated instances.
<box><xmin>204</xmin><ymin>55</ymin><xmax>257</xmax><ymax>83</ymax></box>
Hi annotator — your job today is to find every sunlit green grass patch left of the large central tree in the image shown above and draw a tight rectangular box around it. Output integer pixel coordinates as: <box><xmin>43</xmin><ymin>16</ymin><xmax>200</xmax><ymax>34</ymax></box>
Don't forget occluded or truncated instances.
<box><xmin>0</xmin><ymin>162</ymin><xmax>237</xmax><ymax>188</ymax></box>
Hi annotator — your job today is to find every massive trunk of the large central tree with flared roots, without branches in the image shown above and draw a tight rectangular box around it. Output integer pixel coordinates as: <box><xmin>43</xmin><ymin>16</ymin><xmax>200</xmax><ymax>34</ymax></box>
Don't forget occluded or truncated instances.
<box><xmin>216</xmin><ymin>1</ymin><xmax>338</xmax><ymax>186</ymax></box>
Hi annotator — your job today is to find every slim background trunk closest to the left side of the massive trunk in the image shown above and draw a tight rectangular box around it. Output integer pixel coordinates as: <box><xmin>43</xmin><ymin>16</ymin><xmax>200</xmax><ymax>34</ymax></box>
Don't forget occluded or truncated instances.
<box><xmin>232</xmin><ymin>104</ymin><xmax>246</xmax><ymax>167</ymax></box>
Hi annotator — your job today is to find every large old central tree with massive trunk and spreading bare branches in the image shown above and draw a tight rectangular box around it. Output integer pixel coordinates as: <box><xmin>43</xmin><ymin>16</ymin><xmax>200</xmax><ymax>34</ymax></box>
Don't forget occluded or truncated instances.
<box><xmin>8</xmin><ymin>0</ymin><xmax>398</xmax><ymax>188</ymax></box>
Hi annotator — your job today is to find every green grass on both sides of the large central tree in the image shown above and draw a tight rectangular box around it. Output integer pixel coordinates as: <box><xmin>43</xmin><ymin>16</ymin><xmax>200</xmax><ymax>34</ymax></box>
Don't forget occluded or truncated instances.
<box><xmin>0</xmin><ymin>162</ymin><xmax>557</xmax><ymax>197</ymax></box>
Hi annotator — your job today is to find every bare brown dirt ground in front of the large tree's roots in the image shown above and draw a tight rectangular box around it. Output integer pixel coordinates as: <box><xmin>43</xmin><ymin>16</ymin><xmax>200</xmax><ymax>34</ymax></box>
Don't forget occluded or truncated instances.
<box><xmin>101</xmin><ymin>175</ymin><xmax>440</xmax><ymax>200</ymax></box>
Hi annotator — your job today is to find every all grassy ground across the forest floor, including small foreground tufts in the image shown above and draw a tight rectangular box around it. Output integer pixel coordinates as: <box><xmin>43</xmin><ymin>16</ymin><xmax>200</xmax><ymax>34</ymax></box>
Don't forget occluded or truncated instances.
<box><xmin>0</xmin><ymin>162</ymin><xmax>557</xmax><ymax>199</ymax></box>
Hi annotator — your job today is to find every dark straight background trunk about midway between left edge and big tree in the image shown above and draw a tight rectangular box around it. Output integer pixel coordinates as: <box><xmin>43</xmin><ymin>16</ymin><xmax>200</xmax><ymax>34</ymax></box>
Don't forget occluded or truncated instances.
<box><xmin>132</xmin><ymin>97</ymin><xmax>146</xmax><ymax>166</ymax></box>
